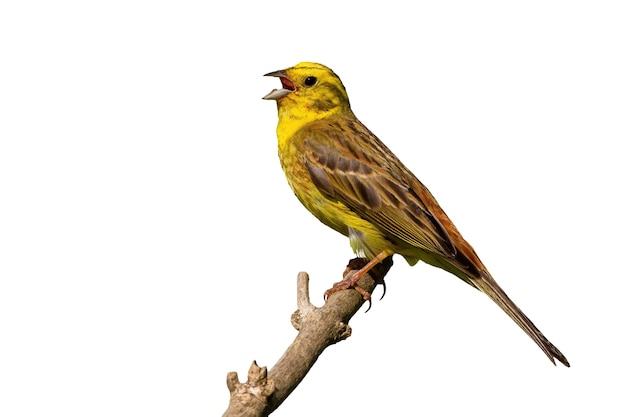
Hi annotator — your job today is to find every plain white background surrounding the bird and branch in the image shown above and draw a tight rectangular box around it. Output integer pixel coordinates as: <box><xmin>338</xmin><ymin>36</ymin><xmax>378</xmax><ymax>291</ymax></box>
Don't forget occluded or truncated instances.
<box><xmin>0</xmin><ymin>1</ymin><xmax>626</xmax><ymax>416</ymax></box>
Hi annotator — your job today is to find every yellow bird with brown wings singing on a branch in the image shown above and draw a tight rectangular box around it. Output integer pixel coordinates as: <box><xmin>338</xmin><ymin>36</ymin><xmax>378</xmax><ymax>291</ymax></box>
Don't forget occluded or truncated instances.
<box><xmin>263</xmin><ymin>62</ymin><xmax>569</xmax><ymax>366</ymax></box>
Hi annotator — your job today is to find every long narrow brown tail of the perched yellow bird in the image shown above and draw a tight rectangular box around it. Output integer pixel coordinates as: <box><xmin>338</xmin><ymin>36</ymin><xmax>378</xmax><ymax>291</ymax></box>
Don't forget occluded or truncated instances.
<box><xmin>470</xmin><ymin>272</ymin><xmax>569</xmax><ymax>367</ymax></box>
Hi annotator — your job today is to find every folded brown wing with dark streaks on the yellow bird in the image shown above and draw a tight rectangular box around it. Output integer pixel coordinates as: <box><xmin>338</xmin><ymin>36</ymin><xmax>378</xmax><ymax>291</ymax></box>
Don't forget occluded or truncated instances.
<box><xmin>294</xmin><ymin>114</ymin><xmax>457</xmax><ymax>258</ymax></box>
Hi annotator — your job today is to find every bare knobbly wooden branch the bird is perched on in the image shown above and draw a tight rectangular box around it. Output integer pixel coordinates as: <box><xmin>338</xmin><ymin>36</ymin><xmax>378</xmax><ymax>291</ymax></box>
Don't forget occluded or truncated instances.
<box><xmin>223</xmin><ymin>257</ymin><xmax>392</xmax><ymax>417</ymax></box>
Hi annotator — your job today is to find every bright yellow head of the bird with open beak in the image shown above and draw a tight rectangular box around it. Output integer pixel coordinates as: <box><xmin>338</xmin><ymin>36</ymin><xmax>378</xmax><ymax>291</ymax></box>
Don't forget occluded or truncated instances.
<box><xmin>263</xmin><ymin>62</ymin><xmax>350</xmax><ymax>136</ymax></box>
